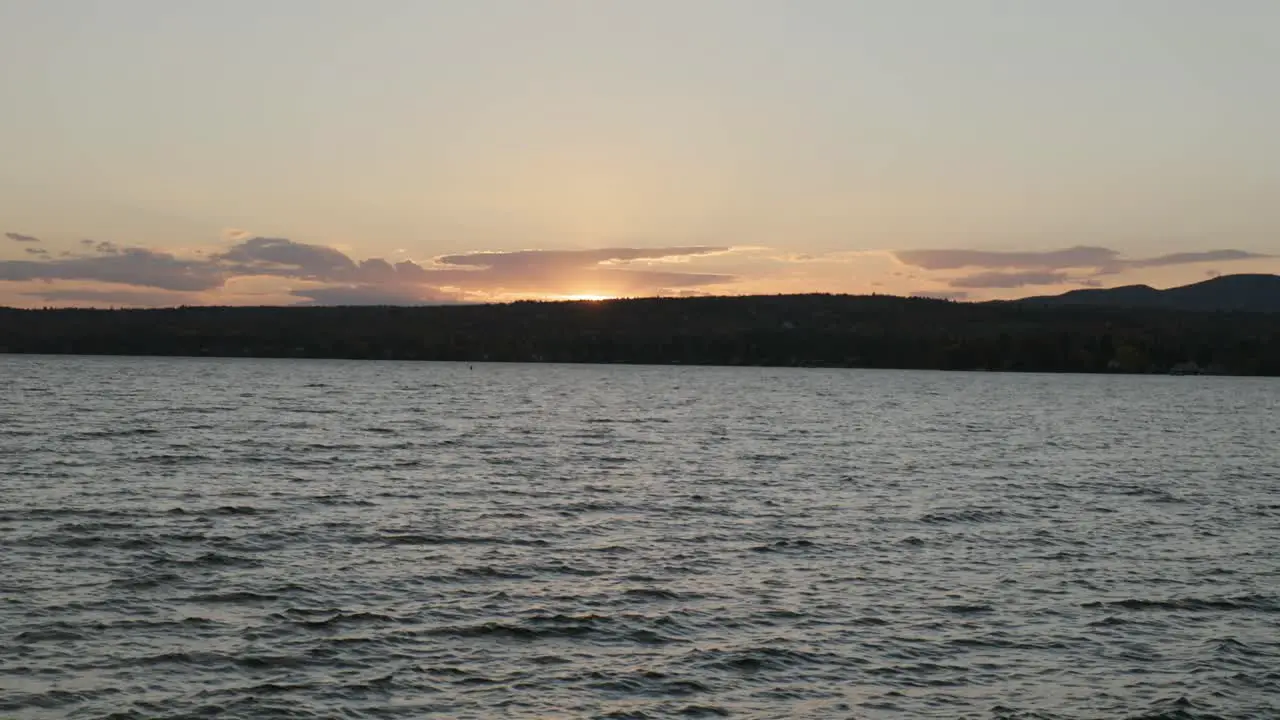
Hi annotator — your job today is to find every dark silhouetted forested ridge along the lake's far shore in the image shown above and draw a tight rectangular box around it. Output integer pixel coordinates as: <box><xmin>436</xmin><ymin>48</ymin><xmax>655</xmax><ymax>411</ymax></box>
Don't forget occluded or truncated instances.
<box><xmin>0</xmin><ymin>295</ymin><xmax>1280</xmax><ymax>375</ymax></box>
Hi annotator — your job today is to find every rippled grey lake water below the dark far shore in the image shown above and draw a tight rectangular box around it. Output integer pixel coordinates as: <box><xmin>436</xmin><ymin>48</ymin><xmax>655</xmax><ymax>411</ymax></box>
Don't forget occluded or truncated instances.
<box><xmin>0</xmin><ymin>356</ymin><xmax>1280</xmax><ymax>719</ymax></box>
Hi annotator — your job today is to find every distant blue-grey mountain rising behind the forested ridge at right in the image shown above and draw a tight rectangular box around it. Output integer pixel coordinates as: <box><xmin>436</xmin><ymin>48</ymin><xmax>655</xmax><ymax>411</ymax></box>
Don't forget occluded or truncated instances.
<box><xmin>1015</xmin><ymin>274</ymin><xmax>1280</xmax><ymax>313</ymax></box>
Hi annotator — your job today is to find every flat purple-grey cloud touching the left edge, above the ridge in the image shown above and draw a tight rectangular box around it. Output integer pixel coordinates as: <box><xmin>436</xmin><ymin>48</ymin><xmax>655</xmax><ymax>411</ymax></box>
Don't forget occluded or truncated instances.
<box><xmin>0</xmin><ymin>246</ymin><xmax>225</xmax><ymax>291</ymax></box>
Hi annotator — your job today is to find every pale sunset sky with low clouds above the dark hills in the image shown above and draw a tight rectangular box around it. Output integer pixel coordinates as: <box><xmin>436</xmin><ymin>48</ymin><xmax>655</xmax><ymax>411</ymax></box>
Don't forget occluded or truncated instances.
<box><xmin>0</xmin><ymin>0</ymin><xmax>1280</xmax><ymax>306</ymax></box>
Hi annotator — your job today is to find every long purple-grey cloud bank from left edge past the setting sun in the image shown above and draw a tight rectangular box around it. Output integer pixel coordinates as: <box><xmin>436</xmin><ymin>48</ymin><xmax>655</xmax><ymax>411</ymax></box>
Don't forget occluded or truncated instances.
<box><xmin>0</xmin><ymin>233</ymin><xmax>735</xmax><ymax>305</ymax></box>
